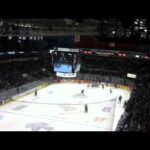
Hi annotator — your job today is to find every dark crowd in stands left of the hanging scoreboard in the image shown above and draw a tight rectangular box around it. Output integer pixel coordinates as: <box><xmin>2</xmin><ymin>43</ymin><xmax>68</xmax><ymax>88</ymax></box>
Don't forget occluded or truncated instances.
<box><xmin>0</xmin><ymin>60</ymin><xmax>52</xmax><ymax>90</ymax></box>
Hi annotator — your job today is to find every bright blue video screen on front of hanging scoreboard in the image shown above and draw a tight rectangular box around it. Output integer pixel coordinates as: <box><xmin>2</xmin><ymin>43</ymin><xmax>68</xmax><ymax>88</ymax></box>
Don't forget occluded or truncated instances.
<box><xmin>54</xmin><ymin>63</ymin><xmax>72</xmax><ymax>73</ymax></box>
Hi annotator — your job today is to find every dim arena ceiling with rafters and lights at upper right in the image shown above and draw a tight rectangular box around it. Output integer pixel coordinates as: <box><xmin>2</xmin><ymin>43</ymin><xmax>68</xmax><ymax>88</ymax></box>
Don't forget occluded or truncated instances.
<box><xmin>0</xmin><ymin>18</ymin><xmax>150</xmax><ymax>40</ymax></box>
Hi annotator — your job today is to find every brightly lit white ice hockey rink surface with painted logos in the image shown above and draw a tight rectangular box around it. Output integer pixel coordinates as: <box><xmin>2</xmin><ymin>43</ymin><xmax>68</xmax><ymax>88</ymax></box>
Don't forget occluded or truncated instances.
<box><xmin>0</xmin><ymin>83</ymin><xmax>130</xmax><ymax>131</ymax></box>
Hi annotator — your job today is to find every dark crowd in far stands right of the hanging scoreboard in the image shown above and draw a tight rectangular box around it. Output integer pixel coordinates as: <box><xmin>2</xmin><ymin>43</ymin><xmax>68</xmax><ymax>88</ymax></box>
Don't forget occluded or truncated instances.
<box><xmin>81</xmin><ymin>57</ymin><xmax>149</xmax><ymax>77</ymax></box>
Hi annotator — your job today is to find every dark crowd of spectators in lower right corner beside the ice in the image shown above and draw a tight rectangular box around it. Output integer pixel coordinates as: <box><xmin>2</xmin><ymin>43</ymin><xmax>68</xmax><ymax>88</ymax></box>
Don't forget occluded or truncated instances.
<box><xmin>117</xmin><ymin>75</ymin><xmax>150</xmax><ymax>131</ymax></box>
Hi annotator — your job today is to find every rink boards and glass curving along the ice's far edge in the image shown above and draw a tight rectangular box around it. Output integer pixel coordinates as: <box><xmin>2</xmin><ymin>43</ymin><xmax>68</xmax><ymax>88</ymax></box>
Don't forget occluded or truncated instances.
<box><xmin>0</xmin><ymin>73</ymin><xmax>134</xmax><ymax>103</ymax></box>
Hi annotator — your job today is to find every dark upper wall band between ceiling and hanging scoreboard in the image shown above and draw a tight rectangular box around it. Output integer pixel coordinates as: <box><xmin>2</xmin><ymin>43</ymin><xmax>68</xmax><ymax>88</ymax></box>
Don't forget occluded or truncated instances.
<box><xmin>0</xmin><ymin>36</ymin><xmax>150</xmax><ymax>53</ymax></box>
